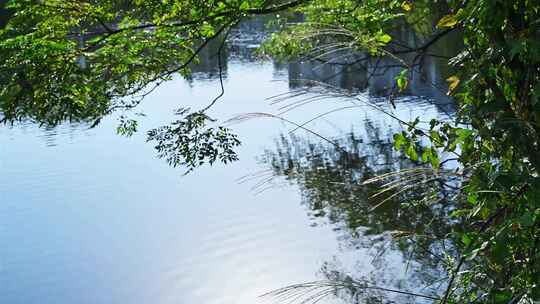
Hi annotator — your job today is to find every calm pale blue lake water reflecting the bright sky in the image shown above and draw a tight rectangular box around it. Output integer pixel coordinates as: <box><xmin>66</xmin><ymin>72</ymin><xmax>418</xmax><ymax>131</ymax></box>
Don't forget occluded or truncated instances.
<box><xmin>0</xmin><ymin>23</ymin><xmax>458</xmax><ymax>304</ymax></box>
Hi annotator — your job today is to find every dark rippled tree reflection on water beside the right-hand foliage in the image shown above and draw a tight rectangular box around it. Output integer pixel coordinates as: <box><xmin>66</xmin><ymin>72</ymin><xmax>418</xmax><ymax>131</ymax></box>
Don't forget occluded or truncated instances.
<box><xmin>262</xmin><ymin>120</ymin><xmax>459</xmax><ymax>303</ymax></box>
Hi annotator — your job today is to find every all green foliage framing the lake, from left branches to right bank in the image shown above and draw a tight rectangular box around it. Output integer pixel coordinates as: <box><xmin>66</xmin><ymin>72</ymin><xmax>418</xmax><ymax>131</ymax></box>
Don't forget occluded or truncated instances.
<box><xmin>0</xmin><ymin>0</ymin><xmax>540</xmax><ymax>303</ymax></box>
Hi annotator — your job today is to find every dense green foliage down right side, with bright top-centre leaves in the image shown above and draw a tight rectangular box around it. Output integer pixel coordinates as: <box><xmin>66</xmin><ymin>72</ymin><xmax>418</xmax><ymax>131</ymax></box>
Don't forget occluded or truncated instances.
<box><xmin>269</xmin><ymin>1</ymin><xmax>540</xmax><ymax>303</ymax></box>
